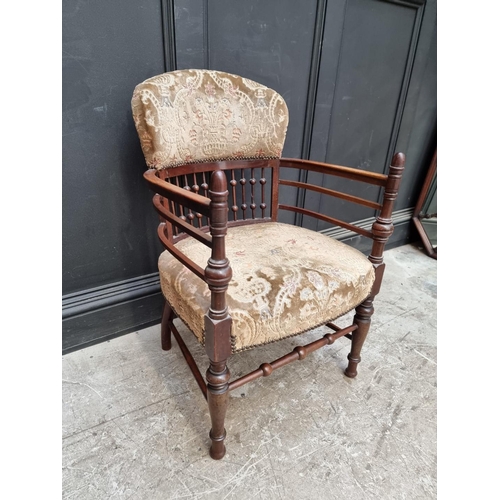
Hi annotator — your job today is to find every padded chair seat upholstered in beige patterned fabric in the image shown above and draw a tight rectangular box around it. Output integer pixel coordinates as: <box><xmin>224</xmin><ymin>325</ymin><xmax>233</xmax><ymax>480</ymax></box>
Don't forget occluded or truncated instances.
<box><xmin>158</xmin><ymin>222</ymin><xmax>375</xmax><ymax>352</ymax></box>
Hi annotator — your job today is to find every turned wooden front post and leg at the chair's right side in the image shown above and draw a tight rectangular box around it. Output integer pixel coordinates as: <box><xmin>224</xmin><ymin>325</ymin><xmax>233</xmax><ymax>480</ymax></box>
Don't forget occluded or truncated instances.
<box><xmin>344</xmin><ymin>153</ymin><xmax>405</xmax><ymax>378</ymax></box>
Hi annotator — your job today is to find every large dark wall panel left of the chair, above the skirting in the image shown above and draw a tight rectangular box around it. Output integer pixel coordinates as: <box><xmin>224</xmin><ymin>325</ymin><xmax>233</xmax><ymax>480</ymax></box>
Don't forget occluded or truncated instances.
<box><xmin>62</xmin><ymin>0</ymin><xmax>164</xmax><ymax>293</ymax></box>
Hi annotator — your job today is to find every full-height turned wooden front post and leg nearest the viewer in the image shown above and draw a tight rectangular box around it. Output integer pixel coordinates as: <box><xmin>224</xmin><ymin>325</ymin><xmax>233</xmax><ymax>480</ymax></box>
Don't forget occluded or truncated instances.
<box><xmin>205</xmin><ymin>170</ymin><xmax>232</xmax><ymax>460</ymax></box>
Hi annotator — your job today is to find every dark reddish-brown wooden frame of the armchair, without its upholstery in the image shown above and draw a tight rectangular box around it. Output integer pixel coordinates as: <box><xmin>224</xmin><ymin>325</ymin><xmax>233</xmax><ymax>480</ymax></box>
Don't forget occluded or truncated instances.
<box><xmin>144</xmin><ymin>153</ymin><xmax>405</xmax><ymax>459</ymax></box>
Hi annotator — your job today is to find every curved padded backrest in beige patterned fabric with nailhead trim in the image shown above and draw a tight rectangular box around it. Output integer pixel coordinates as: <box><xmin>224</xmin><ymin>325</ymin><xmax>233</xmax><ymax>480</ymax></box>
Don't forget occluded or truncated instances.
<box><xmin>132</xmin><ymin>69</ymin><xmax>288</xmax><ymax>169</ymax></box>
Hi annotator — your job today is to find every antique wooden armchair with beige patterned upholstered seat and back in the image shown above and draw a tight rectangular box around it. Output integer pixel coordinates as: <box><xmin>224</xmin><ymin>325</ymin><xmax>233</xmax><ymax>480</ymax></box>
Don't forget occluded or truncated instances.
<box><xmin>132</xmin><ymin>70</ymin><xmax>405</xmax><ymax>459</ymax></box>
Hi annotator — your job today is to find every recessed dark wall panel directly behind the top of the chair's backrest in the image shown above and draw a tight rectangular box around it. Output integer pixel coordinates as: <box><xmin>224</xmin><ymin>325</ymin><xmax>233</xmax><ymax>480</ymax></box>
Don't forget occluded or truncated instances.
<box><xmin>208</xmin><ymin>0</ymin><xmax>316</xmax><ymax>157</ymax></box>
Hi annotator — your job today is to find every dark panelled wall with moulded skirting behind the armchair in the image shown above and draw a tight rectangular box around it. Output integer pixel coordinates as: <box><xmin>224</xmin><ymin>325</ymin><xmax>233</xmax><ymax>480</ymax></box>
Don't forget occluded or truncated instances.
<box><xmin>62</xmin><ymin>0</ymin><xmax>436</xmax><ymax>352</ymax></box>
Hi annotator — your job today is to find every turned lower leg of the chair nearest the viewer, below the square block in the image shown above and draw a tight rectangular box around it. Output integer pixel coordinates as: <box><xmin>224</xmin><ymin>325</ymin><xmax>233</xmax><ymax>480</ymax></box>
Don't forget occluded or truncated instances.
<box><xmin>207</xmin><ymin>360</ymin><xmax>230</xmax><ymax>460</ymax></box>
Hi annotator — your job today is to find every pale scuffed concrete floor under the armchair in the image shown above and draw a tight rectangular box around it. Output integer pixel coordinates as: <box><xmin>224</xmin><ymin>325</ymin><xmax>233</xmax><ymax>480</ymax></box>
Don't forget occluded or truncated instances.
<box><xmin>62</xmin><ymin>245</ymin><xmax>437</xmax><ymax>500</ymax></box>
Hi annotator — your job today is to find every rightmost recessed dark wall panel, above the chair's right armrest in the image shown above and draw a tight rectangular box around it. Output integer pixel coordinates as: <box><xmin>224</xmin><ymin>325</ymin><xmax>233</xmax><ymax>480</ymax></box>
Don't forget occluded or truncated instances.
<box><xmin>323</xmin><ymin>0</ymin><xmax>415</xmax><ymax>168</ymax></box>
